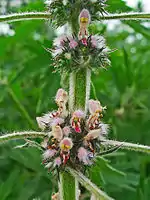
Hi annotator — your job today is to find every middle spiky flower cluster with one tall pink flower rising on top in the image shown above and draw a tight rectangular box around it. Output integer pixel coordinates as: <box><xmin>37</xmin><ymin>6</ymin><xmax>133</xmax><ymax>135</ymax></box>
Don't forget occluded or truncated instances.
<box><xmin>47</xmin><ymin>9</ymin><xmax>110</xmax><ymax>73</ymax></box>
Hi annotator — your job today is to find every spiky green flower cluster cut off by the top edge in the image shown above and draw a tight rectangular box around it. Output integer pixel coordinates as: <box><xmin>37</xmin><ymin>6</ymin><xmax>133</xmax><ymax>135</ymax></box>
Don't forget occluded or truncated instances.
<box><xmin>45</xmin><ymin>0</ymin><xmax>107</xmax><ymax>27</ymax></box>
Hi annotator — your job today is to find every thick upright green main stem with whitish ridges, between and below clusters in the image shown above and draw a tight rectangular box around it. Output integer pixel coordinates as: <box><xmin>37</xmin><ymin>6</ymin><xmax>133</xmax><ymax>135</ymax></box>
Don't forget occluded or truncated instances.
<box><xmin>59</xmin><ymin>69</ymin><xmax>91</xmax><ymax>200</ymax></box>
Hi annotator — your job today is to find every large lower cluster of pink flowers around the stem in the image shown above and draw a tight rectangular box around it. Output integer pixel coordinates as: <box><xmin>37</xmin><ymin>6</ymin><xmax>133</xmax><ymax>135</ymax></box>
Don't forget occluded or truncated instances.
<box><xmin>37</xmin><ymin>89</ymin><xmax>108</xmax><ymax>169</ymax></box>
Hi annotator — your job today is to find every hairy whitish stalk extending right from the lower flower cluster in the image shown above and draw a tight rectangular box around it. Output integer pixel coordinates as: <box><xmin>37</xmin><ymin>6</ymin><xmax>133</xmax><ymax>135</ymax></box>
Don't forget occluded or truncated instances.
<box><xmin>103</xmin><ymin>140</ymin><xmax>150</xmax><ymax>153</ymax></box>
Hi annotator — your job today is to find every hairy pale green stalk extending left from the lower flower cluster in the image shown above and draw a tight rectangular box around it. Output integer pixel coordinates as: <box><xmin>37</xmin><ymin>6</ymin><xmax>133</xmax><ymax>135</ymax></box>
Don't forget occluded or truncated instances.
<box><xmin>0</xmin><ymin>131</ymin><xmax>46</xmax><ymax>144</ymax></box>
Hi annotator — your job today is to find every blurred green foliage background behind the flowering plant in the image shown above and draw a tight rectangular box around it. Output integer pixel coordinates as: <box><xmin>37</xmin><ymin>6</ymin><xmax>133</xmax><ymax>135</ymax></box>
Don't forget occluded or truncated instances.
<box><xmin>0</xmin><ymin>0</ymin><xmax>150</xmax><ymax>200</ymax></box>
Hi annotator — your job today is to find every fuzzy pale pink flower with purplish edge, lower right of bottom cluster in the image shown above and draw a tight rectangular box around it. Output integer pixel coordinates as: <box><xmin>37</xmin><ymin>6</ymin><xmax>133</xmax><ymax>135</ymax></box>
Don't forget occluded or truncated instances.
<box><xmin>78</xmin><ymin>147</ymin><xmax>93</xmax><ymax>165</ymax></box>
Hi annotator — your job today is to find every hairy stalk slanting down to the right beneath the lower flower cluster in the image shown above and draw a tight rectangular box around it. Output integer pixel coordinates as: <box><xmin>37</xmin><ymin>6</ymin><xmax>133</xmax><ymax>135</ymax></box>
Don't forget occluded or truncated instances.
<box><xmin>67</xmin><ymin>167</ymin><xmax>113</xmax><ymax>200</ymax></box>
